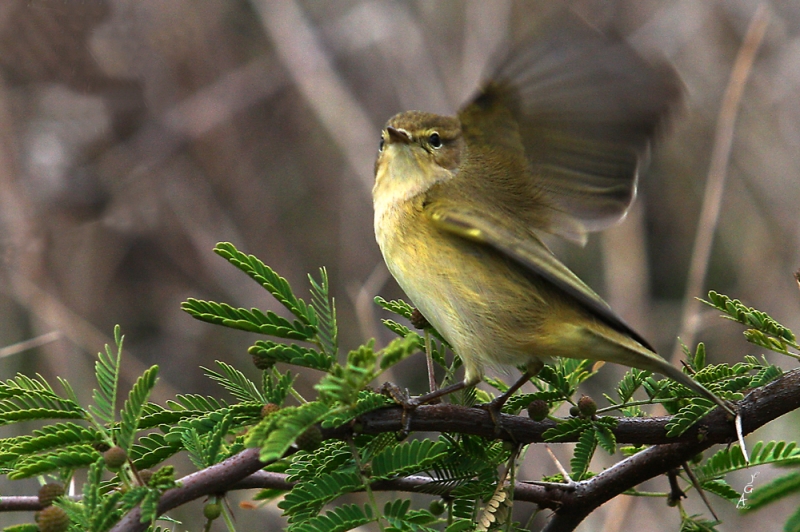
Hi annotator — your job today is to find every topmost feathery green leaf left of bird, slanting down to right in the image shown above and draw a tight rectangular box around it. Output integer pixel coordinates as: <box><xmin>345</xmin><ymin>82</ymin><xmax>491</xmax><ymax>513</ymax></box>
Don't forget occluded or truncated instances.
<box><xmin>214</xmin><ymin>242</ymin><xmax>317</xmax><ymax>327</ymax></box>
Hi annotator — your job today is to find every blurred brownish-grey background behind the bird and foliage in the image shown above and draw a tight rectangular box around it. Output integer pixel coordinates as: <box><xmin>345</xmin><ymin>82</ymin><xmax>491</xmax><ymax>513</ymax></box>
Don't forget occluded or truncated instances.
<box><xmin>0</xmin><ymin>0</ymin><xmax>800</xmax><ymax>532</ymax></box>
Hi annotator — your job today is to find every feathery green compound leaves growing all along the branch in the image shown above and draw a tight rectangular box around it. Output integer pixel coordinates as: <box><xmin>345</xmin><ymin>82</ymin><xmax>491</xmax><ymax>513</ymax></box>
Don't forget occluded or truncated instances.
<box><xmin>0</xmin><ymin>243</ymin><xmax>800</xmax><ymax>532</ymax></box>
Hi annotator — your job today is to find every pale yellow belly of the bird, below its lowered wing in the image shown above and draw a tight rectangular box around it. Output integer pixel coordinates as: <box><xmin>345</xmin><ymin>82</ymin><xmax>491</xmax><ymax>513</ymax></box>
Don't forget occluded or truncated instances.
<box><xmin>379</xmin><ymin>216</ymin><xmax>547</xmax><ymax>381</ymax></box>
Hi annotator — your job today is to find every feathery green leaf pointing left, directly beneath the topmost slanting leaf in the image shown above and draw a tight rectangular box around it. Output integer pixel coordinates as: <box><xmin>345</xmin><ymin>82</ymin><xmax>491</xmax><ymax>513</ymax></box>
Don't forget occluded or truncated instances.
<box><xmin>181</xmin><ymin>298</ymin><xmax>316</xmax><ymax>340</ymax></box>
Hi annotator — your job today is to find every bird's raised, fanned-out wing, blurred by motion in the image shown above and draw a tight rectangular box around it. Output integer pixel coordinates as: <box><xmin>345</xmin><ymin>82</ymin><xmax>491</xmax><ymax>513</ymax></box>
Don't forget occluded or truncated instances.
<box><xmin>458</xmin><ymin>9</ymin><xmax>683</xmax><ymax>242</ymax></box>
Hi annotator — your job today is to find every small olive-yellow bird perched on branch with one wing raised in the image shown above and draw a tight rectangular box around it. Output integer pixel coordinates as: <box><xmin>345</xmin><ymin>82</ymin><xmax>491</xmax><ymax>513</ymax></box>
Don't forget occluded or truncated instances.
<box><xmin>373</xmin><ymin>13</ymin><xmax>730</xmax><ymax>416</ymax></box>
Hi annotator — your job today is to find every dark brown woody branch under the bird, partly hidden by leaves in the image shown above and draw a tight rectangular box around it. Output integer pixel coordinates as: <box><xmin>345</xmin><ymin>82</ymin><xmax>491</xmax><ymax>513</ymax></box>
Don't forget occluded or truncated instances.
<box><xmin>100</xmin><ymin>369</ymin><xmax>800</xmax><ymax>532</ymax></box>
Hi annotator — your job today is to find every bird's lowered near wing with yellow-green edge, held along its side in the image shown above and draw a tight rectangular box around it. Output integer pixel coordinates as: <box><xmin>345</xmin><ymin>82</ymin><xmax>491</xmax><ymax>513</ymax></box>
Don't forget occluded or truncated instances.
<box><xmin>425</xmin><ymin>201</ymin><xmax>655</xmax><ymax>351</ymax></box>
